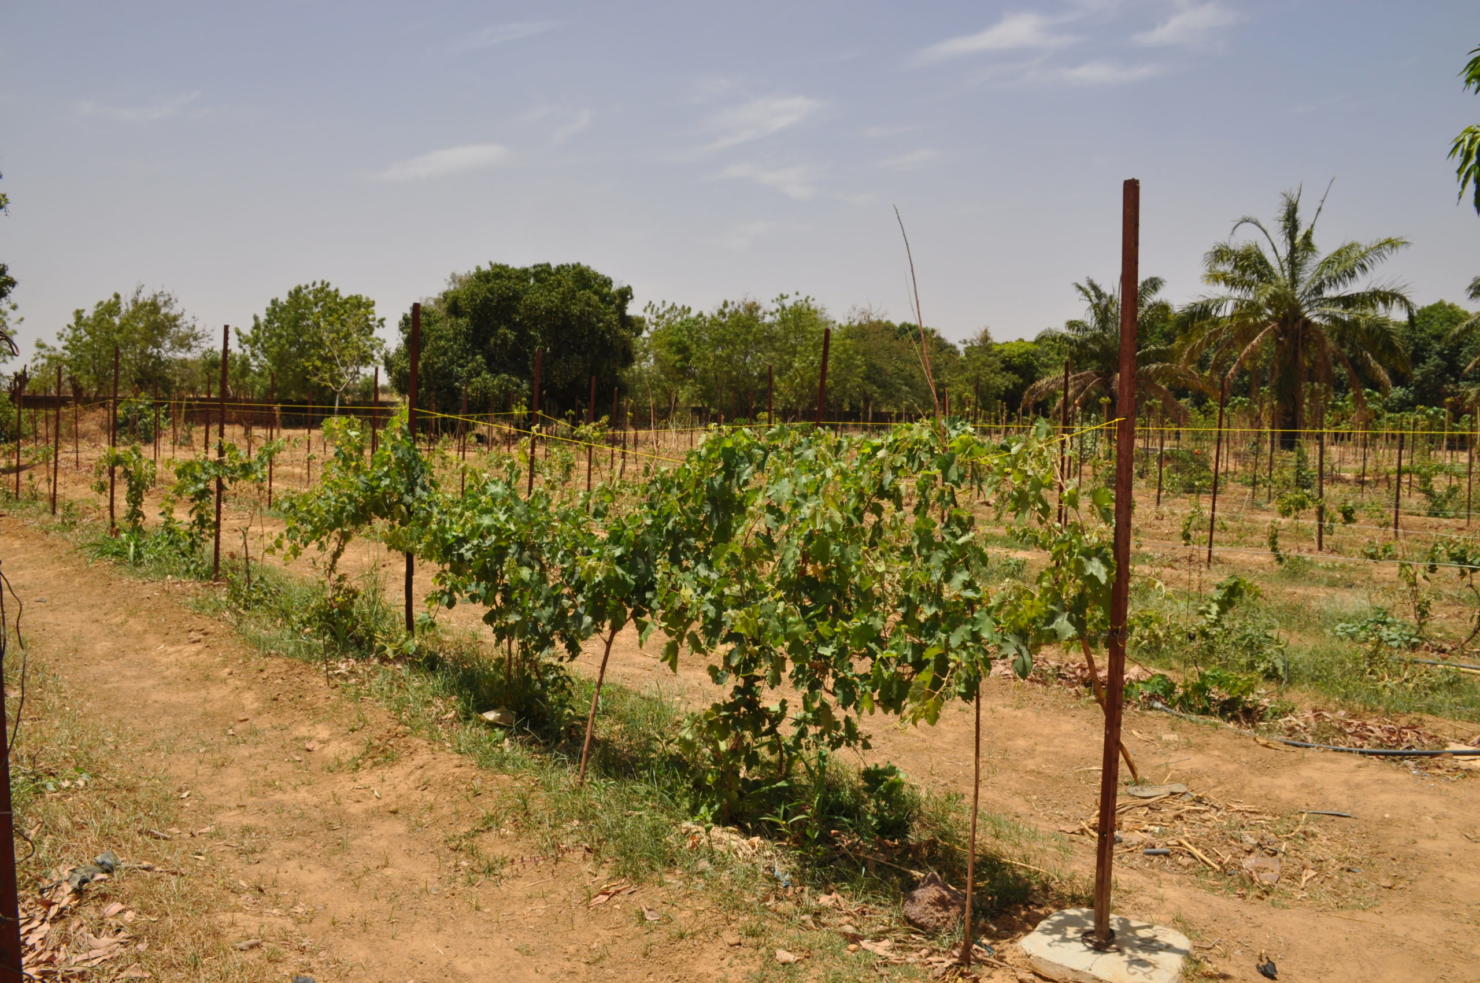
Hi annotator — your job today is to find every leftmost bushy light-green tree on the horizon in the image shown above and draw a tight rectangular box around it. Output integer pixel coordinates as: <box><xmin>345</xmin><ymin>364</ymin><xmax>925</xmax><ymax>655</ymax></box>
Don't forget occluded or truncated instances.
<box><xmin>37</xmin><ymin>287</ymin><xmax>204</xmax><ymax>392</ymax></box>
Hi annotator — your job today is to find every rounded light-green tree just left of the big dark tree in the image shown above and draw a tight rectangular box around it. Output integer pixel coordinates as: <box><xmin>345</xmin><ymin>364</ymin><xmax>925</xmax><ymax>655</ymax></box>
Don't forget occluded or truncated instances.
<box><xmin>241</xmin><ymin>280</ymin><xmax>385</xmax><ymax>413</ymax></box>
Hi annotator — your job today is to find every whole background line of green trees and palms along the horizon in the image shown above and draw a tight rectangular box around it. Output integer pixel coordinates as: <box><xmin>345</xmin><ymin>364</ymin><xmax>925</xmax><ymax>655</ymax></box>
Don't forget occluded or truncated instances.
<box><xmin>8</xmin><ymin>191</ymin><xmax>1480</xmax><ymax>428</ymax></box>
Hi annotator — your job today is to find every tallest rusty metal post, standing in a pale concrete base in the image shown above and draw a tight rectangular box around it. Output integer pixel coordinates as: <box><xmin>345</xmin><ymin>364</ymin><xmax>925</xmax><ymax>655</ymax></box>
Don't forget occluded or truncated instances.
<box><xmin>1091</xmin><ymin>178</ymin><xmax>1141</xmax><ymax>946</ymax></box>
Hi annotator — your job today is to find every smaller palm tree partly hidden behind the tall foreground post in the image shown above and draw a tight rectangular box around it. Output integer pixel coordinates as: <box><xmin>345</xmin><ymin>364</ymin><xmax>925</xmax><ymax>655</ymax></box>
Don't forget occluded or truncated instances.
<box><xmin>1023</xmin><ymin>277</ymin><xmax>1209</xmax><ymax>419</ymax></box>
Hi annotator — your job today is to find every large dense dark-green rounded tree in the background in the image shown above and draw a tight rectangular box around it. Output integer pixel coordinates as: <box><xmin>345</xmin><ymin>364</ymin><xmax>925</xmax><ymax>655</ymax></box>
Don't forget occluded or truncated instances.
<box><xmin>385</xmin><ymin>264</ymin><xmax>641</xmax><ymax>412</ymax></box>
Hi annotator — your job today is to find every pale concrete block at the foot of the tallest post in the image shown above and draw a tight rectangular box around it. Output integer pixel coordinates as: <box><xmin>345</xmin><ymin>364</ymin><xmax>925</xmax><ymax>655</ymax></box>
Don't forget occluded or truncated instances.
<box><xmin>1018</xmin><ymin>907</ymin><xmax>1191</xmax><ymax>983</ymax></box>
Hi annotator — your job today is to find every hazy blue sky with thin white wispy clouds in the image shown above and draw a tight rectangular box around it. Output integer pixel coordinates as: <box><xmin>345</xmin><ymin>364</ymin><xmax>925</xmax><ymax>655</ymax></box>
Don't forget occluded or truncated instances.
<box><xmin>0</xmin><ymin>0</ymin><xmax>1480</xmax><ymax>361</ymax></box>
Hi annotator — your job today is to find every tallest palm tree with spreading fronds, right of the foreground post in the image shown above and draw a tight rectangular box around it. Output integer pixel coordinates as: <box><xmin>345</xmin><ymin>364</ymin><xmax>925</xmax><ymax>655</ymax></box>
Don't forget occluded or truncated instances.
<box><xmin>1185</xmin><ymin>189</ymin><xmax>1413</xmax><ymax>447</ymax></box>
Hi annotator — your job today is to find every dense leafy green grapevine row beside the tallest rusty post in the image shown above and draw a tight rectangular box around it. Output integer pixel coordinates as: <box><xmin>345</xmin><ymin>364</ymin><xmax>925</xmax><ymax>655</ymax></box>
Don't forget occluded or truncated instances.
<box><xmin>275</xmin><ymin>411</ymin><xmax>1113</xmax><ymax>832</ymax></box>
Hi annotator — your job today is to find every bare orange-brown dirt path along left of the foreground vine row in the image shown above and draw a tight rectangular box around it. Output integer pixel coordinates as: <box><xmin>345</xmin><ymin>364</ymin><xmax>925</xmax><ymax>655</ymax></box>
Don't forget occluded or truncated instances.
<box><xmin>0</xmin><ymin>517</ymin><xmax>759</xmax><ymax>983</ymax></box>
